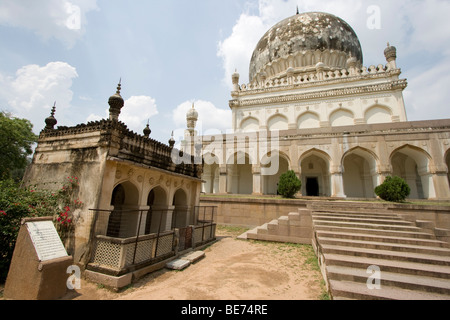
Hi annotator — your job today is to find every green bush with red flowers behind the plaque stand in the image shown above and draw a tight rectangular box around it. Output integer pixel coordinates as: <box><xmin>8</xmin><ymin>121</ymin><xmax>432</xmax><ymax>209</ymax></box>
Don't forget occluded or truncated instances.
<box><xmin>0</xmin><ymin>177</ymin><xmax>82</xmax><ymax>283</ymax></box>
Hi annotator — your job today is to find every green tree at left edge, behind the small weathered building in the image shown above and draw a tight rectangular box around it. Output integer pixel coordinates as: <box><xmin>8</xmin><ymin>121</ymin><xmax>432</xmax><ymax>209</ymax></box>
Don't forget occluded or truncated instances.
<box><xmin>0</xmin><ymin>111</ymin><xmax>37</xmax><ymax>180</ymax></box>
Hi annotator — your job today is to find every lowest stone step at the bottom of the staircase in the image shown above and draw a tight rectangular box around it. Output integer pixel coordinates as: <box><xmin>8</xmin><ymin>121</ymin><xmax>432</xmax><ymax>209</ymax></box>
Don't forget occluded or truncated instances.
<box><xmin>330</xmin><ymin>280</ymin><xmax>450</xmax><ymax>300</ymax></box>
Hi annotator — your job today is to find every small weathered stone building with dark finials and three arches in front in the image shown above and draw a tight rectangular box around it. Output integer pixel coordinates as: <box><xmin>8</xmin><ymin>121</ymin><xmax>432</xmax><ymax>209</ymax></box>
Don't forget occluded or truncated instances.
<box><xmin>24</xmin><ymin>85</ymin><xmax>209</xmax><ymax>273</ymax></box>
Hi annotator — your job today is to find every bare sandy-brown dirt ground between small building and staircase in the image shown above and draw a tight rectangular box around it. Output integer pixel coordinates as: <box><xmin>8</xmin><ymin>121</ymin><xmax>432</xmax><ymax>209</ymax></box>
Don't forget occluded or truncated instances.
<box><xmin>1</xmin><ymin>227</ymin><xmax>327</xmax><ymax>300</ymax></box>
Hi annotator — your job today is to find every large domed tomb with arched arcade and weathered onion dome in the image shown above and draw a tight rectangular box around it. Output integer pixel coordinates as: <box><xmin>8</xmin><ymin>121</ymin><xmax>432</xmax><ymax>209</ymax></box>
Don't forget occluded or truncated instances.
<box><xmin>194</xmin><ymin>12</ymin><xmax>450</xmax><ymax>199</ymax></box>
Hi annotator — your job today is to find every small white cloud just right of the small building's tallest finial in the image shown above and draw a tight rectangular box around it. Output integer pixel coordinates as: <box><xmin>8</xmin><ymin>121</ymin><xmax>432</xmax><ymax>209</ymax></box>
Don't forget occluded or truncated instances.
<box><xmin>119</xmin><ymin>96</ymin><xmax>158</xmax><ymax>134</ymax></box>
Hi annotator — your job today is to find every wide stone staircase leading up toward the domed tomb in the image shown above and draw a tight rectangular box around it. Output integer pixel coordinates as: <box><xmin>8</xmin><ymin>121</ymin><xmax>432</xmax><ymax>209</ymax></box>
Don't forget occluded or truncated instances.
<box><xmin>312</xmin><ymin>207</ymin><xmax>450</xmax><ymax>300</ymax></box>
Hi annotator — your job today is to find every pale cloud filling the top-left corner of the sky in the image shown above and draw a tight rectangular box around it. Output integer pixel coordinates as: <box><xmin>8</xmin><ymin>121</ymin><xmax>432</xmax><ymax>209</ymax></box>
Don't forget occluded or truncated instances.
<box><xmin>0</xmin><ymin>0</ymin><xmax>97</xmax><ymax>47</ymax></box>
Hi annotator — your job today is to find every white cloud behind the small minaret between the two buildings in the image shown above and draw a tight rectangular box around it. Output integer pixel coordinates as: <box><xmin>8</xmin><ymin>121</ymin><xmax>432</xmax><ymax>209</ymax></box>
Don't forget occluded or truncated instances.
<box><xmin>172</xmin><ymin>100</ymin><xmax>231</xmax><ymax>135</ymax></box>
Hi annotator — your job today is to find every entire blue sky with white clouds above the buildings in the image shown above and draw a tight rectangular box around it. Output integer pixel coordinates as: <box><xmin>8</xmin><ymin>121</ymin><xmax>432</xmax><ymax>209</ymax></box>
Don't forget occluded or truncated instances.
<box><xmin>0</xmin><ymin>0</ymin><xmax>450</xmax><ymax>143</ymax></box>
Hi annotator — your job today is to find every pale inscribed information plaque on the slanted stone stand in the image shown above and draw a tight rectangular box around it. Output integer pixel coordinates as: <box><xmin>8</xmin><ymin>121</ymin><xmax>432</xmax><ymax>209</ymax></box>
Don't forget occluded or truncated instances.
<box><xmin>26</xmin><ymin>221</ymin><xmax>68</xmax><ymax>261</ymax></box>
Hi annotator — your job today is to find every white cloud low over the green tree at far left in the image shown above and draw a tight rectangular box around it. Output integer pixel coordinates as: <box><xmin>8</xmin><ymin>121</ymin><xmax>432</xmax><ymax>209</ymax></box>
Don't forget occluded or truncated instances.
<box><xmin>0</xmin><ymin>62</ymin><xmax>78</xmax><ymax>131</ymax></box>
